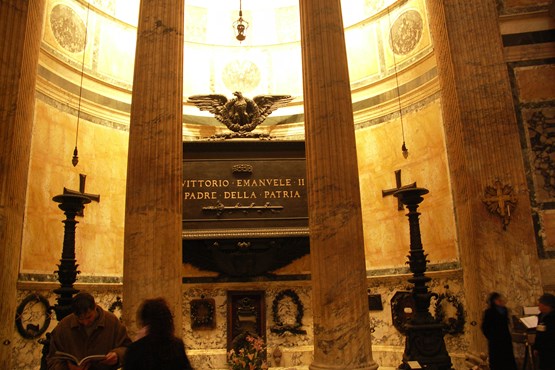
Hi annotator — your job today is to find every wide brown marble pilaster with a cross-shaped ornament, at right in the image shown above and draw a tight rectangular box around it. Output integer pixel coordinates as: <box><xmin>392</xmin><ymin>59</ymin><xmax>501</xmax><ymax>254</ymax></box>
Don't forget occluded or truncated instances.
<box><xmin>427</xmin><ymin>0</ymin><xmax>542</xmax><ymax>351</ymax></box>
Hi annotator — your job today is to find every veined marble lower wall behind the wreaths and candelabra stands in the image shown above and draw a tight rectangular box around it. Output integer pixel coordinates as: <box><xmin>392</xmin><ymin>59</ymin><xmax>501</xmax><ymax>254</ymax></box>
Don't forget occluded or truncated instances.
<box><xmin>11</xmin><ymin>270</ymin><xmax>476</xmax><ymax>370</ymax></box>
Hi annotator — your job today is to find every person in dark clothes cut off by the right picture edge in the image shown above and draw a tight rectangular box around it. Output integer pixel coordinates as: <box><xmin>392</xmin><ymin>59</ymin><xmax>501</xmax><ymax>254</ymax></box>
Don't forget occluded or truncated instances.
<box><xmin>534</xmin><ymin>293</ymin><xmax>555</xmax><ymax>370</ymax></box>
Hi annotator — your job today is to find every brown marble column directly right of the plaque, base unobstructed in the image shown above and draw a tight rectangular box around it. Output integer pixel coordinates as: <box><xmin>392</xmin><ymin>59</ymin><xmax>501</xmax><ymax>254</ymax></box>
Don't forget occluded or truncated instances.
<box><xmin>299</xmin><ymin>0</ymin><xmax>378</xmax><ymax>370</ymax></box>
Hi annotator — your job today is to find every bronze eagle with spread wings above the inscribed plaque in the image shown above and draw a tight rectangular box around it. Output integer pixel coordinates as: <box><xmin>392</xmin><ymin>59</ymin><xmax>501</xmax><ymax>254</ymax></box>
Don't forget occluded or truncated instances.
<box><xmin>187</xmin><ymin>91</ymin><xmax>293</xmax><ymax>133</ymax></box>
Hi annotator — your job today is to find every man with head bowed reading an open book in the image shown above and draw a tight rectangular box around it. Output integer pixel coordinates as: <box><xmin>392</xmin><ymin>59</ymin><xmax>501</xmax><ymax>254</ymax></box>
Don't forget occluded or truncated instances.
<box><xmin>47</xmin><ymin>293</ymin><xmax>131</xmax><ymax>370</ymax></box>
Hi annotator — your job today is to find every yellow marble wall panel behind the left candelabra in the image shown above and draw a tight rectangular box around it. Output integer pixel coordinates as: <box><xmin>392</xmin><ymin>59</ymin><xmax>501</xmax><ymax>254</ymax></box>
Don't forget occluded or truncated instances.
<box><xmin>20</xmin><ymin>99</ymin><xmax>128</xmax><ymax>276</ymax></box>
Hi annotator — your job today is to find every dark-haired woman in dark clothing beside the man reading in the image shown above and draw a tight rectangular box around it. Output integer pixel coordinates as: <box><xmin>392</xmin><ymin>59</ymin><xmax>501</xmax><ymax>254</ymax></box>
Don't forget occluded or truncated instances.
<box><xmin>123</xmin><ymin>298</ymin><xmax>192</xmax><ymax>370</ymax></box>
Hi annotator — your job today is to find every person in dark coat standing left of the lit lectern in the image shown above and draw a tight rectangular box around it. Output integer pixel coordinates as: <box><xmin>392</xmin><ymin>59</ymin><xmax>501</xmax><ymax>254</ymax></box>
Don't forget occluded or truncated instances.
<box><xmin>482</xmin><ymin>292</ymin><xmax>517</xmax><ymax>370</ymax></box>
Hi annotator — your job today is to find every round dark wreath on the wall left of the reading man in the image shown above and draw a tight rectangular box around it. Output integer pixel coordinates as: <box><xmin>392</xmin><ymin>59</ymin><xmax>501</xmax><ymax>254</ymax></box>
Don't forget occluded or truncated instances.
<box><xmin>15</xmin><ymin>293</ymin><xmax>52</xmax><ymax>339</ymax></box>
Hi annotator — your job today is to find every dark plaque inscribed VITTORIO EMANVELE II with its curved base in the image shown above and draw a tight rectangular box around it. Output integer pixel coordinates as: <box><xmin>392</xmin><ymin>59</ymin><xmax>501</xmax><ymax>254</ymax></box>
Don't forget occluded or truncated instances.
<box><xmin>182</xmin><ymin>140</ymin><xmax>310</xmax><ymax>276</ymax></box>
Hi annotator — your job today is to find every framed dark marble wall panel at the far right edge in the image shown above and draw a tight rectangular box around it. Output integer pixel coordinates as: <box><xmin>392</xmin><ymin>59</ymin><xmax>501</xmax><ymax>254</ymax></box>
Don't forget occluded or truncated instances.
<box><xmin>508</xmin><ymin>57</ymin><xmax>555</xmax><ymax>278</ymax></box>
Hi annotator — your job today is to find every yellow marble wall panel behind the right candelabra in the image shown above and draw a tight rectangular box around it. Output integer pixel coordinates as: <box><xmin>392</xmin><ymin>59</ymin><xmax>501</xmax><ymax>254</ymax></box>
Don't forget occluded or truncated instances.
<box><xmin>356</xmin><ymin>100</ymin><xmax>458</xmax><ymax>270</ymax></box>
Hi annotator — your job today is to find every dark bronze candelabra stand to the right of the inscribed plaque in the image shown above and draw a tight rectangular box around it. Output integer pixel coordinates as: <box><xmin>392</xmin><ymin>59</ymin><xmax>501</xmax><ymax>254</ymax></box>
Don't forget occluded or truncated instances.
<box><xmin>394</xmin><ymin>188</ymin><xmax>453</xmax><ymax>370</ymax></box>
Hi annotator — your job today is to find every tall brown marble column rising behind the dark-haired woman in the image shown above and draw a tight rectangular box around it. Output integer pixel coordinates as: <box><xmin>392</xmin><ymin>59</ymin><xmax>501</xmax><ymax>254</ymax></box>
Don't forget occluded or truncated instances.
<box><xmin>123</xmin><ymin>0</ymin><xmax>184</xmax><ymax>335</ymax></box>
